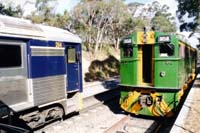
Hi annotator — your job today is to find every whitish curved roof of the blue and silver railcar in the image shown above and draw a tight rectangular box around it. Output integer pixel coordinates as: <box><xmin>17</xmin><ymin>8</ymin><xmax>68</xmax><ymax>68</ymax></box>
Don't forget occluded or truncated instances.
<box><xmin>0</xmin><ymin>15</ymin><xmax>81</xmax><ymax>43</ymax></box>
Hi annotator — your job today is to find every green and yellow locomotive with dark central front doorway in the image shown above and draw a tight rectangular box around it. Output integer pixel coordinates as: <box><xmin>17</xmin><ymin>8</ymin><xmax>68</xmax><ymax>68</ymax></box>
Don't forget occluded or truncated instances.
<box><xmin>120</xmin><ymin>31</ymin><xmax>197</xmax><ymax>117</ymax></box>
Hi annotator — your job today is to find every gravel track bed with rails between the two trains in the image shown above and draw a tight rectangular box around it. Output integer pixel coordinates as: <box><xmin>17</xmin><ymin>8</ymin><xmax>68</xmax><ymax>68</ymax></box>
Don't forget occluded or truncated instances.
<box><xmin>35</xmin><ymin>77</ymin><xmax>195</xmax><ymax>133</ymax></box>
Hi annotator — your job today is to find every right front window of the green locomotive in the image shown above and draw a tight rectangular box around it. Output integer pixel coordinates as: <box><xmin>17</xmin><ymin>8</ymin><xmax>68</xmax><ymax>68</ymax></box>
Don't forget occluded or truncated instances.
<box><xmin>159</xmin><ymin>43</ymin><xmax>174</xmax><ymax>57</ymax></box>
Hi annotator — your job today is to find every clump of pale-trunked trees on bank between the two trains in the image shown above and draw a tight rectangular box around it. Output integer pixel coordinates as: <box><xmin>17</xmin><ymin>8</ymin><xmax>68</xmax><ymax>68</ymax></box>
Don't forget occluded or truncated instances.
<box><xmin>72</xmin><ymin>0</ymin><xmax>133</xmax><ymax>53</ymax></box>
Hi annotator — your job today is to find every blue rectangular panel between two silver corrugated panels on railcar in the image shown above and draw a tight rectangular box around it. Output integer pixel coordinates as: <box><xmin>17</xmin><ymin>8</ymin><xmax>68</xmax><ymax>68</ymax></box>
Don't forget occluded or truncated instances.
<box><xmin>31</xmin><ymin>56</ymin><xmax>66</xmax><ymax>78</ymax></box>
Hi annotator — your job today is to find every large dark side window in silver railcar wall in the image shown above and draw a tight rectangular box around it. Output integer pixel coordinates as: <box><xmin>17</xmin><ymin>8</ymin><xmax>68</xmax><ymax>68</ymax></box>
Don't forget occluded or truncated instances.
<box><xmin>0</xmin><ymin>45</ymin><xmax>22</xmax><ymax>68</ymax></box>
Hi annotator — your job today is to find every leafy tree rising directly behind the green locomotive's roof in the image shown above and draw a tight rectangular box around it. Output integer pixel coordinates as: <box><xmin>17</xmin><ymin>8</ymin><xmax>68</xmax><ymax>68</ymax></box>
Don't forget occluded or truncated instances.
<box><xmin>134</xmin><ymin>1</ymin><xmax>176</xmax><ymax>32</ymax></box>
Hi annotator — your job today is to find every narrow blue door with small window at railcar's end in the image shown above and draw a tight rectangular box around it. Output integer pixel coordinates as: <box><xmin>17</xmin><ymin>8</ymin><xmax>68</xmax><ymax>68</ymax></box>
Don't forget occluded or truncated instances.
<box><xmin>65</xmin><ymin>45</ymin><xmax>81</xmax><ymax>92</ymax></box>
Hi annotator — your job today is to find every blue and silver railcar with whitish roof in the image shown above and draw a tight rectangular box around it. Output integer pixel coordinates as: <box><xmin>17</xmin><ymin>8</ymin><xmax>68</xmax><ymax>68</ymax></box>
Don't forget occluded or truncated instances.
<box><xmin>0</xmin><ymin>15</ymin><xmax>83</xmax><ymax>128</ymax></box>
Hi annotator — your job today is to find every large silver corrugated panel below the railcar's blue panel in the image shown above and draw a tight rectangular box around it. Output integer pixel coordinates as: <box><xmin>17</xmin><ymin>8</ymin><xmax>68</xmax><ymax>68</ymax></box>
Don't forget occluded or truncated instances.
<box><xmin>33</xmin><ymin>75</ymin><xmax>66</xmax><ymax>106</ymax></box>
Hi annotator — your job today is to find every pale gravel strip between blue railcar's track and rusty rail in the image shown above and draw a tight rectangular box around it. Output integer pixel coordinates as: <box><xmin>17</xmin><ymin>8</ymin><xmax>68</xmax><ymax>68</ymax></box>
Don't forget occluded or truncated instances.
<box><xmin>37</xmin><ymin>100</ymin><xmax>125</xmax><ymax>133</ymax></box>
